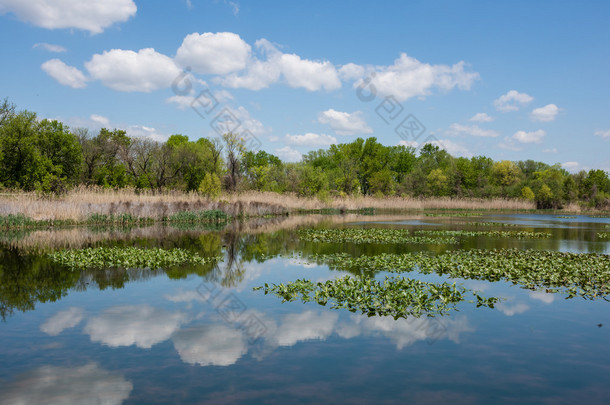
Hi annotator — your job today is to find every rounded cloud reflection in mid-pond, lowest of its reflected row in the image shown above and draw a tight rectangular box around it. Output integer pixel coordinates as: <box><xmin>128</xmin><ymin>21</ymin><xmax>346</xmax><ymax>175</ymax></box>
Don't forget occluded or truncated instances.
<box><xmin>172</xmin><ymin>325</ymin><xmax>248</xmax><ymax>366</ymax></box>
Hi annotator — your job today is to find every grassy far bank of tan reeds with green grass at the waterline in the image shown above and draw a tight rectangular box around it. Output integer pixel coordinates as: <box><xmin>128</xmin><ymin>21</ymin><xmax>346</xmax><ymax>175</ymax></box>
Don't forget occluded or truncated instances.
<box><xmin>0</xmin><ymin>188</ymin><xmax>600</xmax><ymax>229</ymax></box>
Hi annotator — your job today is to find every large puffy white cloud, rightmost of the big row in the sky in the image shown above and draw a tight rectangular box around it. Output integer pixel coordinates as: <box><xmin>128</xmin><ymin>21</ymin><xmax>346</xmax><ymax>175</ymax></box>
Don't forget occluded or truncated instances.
<box><xmin>354</xmin><ymin>53</ymin><xmax>479</xmax><ymax>101</ymax></box>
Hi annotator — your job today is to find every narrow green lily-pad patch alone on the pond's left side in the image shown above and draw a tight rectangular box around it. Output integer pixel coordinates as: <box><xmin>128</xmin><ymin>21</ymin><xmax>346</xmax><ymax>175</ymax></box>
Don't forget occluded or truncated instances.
<box><xmin>49</xmin><ymin>247</ymin><xmax>219</xmax><ymax>270</ymax></box>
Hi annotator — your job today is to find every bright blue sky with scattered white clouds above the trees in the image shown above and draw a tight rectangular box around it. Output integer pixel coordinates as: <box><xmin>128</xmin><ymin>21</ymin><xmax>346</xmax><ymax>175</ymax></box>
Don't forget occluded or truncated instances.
<box><xmin>0</xmin><ymin>0</ymin><xmax>610</xmax><ymax>172</ymax></box>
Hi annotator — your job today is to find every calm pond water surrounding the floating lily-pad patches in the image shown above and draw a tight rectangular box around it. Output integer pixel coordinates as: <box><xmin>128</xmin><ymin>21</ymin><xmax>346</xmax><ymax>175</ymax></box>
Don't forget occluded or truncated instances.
<box><xmin>0</xmin><ymin>214</ymin><xmax>610</xmax><ymax>404</ymax></box>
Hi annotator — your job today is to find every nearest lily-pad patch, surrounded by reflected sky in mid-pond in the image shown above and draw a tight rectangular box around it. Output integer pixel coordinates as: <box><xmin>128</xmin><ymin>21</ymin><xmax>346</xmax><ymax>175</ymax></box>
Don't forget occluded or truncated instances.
<box><xmin>254</xmin><ymin>276</ymin><xmax>498</xmax><ymax>319</ymax></box>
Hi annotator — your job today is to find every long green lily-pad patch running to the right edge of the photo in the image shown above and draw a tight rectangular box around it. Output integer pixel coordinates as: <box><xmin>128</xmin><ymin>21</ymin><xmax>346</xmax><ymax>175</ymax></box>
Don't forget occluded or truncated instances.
<box><xmin>311</xmin><ymin>249</ymin><xmax>610</xmax><ymax>299</ymax></box>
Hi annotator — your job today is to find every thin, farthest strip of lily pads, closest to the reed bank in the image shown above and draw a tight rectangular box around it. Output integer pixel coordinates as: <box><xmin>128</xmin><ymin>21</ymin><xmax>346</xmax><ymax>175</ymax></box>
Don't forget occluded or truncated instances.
<box><xmin>297</xmin><ymin>228</ymin><xmax>458</xmax><ymax>245</ymax></box>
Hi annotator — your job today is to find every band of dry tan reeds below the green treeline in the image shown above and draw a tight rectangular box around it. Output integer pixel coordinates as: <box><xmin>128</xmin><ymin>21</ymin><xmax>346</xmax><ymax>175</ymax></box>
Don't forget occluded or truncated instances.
<box><xmin>0</xmin><ymin>187</ymin><xmax>556</xmax><ymax>222</ymax></box>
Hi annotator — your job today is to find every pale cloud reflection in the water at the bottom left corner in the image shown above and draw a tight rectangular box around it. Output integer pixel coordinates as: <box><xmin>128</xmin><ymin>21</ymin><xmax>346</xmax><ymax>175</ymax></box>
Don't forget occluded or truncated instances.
<box><xmin>0</xmin><ymin>363</ymin><xmax>133</xmax><ymax>405</ymax></box>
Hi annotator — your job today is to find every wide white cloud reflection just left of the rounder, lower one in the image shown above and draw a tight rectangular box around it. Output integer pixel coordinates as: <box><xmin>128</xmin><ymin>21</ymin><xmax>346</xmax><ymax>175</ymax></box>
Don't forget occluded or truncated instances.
<box><xmin>84</xmin><ymin>305</ymin><xmax>186</xmax><ymax>349</ymax></box>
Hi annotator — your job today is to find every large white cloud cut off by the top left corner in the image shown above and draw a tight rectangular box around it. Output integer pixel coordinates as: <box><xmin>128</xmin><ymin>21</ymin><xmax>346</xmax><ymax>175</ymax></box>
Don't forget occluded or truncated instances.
<box><xmin>0</xmin><ymin>0</ymin><xmax>137</xmax><ymax>34</ymax></box>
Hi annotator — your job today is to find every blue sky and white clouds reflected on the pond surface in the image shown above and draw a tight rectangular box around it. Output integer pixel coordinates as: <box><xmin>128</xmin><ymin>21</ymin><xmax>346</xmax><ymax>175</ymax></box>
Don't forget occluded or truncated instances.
<box><xmin>0</xmin><ymin>218</ymin><xmax>610</xmax><ymax>403</ymax></box>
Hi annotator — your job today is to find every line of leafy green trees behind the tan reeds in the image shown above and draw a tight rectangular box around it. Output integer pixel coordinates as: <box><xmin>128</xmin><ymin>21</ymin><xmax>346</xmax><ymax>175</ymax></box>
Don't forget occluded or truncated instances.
<box><xmin>0</xmin><ymin>100</ymin><xmax>610</xmax><ymax>208</ymax></box>
